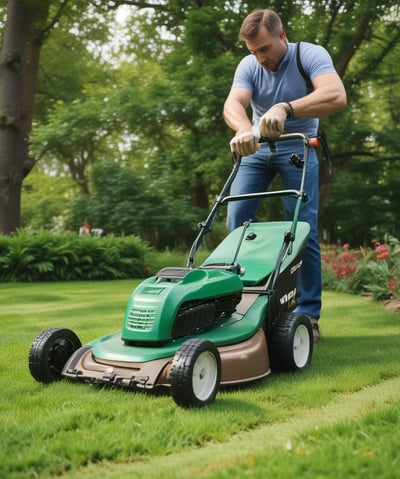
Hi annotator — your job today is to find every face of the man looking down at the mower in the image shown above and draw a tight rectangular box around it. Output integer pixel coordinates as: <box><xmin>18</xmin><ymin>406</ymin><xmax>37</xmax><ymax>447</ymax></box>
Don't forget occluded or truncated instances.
<box><xmin>246</xmin><ymin>27</ymin><xmax>287</xmax><ymax>72</ymax></box>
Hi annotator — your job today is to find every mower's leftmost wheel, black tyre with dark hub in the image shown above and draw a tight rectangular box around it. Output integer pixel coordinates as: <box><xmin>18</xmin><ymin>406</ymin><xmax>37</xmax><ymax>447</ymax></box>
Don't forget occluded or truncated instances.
<box><xmin>29</xmin><ymin>328</ymin><xmax>82</xmax><ymax>383</ymax></box>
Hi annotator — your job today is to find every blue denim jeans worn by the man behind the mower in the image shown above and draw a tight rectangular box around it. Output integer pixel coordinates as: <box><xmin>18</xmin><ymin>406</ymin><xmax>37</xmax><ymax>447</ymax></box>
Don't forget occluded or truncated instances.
<box><xmin>227</xmin><ymin>140</ymin><xmax>322</xmax><ymax>319</ymax></box>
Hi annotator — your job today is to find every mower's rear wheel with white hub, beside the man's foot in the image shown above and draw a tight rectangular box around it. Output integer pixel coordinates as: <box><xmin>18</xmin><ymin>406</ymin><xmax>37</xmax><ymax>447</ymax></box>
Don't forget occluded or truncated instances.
<box><xmin>268</xmin><ymin>311</ymin><xmax>313</xmax><ymax>371</ymax></box>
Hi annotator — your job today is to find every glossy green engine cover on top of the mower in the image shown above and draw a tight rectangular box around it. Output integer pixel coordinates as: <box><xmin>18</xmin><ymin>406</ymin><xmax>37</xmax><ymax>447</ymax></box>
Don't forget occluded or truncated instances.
<box><xmin>122</xmin><ymin>268</ymin><xmax>243</xmax><ymax>345</ymax></box>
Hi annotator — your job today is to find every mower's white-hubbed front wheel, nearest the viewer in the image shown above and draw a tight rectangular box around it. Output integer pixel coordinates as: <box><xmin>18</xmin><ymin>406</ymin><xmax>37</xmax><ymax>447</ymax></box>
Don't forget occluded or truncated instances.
<box><xmin>169</xmin><ymin>339</ymin><xmax>221</xmax><ymax>408</ymax></box>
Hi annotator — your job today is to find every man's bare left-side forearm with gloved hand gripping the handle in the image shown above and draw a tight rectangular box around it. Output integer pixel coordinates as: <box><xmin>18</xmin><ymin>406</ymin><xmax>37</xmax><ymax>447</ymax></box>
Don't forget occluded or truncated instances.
<box><xmin>224</xmin><ymin>87</ymin><xmax>259</xmax><ymax>156</ymax></box>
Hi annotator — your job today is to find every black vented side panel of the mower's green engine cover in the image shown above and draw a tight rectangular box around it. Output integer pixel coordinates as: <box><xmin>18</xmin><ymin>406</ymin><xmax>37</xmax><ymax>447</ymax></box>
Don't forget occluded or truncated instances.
<box><xmin>172</xmin><ymin>293</ymin><xmax>240</xmax><ymax>338</ymax></box>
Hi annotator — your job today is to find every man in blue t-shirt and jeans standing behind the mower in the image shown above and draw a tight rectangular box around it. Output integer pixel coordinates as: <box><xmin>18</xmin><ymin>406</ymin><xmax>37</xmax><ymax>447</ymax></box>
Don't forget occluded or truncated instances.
<box><xmin>224</xmin><ymin>9</ymin><xmax>347</xmax><ymax>342</ymax></box>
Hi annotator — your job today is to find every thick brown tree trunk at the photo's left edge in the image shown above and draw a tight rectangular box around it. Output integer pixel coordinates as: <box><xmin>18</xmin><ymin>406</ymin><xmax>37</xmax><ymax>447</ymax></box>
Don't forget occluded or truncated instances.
<box><xmin>0</xmin><ymin>0</ymin><xmax>50</xmax><ymax>234</ymax></box>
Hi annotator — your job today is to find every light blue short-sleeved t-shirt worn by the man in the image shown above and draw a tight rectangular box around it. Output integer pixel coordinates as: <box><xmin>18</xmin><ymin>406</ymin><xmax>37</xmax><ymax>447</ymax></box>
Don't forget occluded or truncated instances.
<box><xmin>232</xmin><ymin>42</ymin><xmax>336</xmax><ymax>136</ymax></box>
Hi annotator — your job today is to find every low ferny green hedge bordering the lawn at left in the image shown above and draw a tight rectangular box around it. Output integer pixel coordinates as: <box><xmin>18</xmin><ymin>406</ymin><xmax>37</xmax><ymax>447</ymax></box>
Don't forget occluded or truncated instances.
<box><xmin>0</xmin><ymin>230</ymin><xmax>150</xmax><ymax>283</ymax></box>
